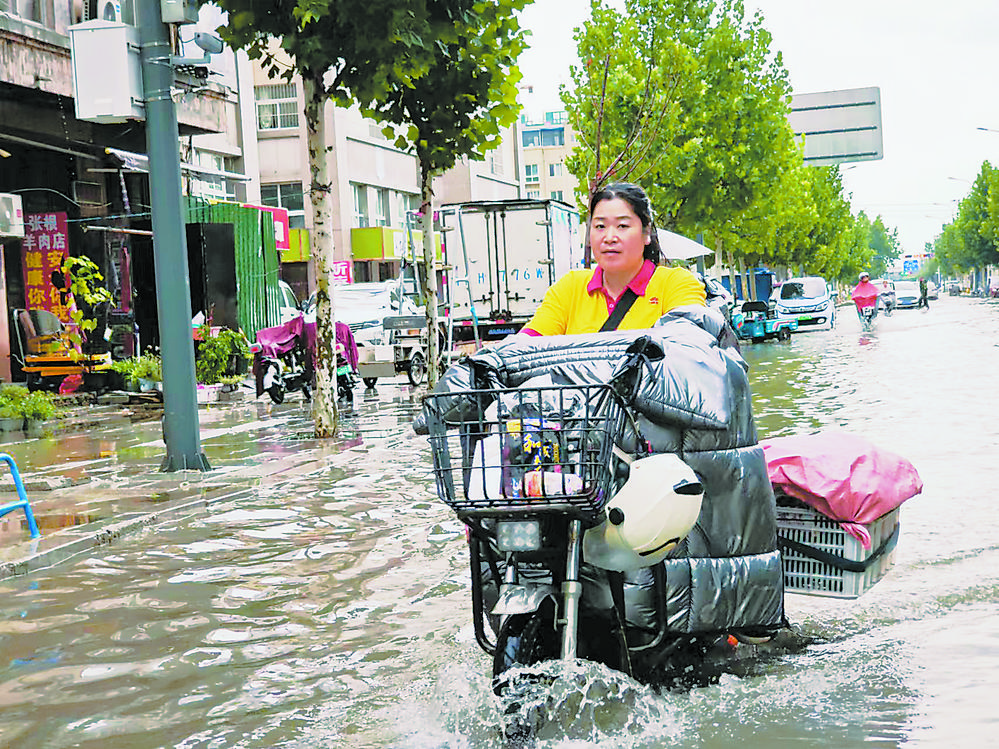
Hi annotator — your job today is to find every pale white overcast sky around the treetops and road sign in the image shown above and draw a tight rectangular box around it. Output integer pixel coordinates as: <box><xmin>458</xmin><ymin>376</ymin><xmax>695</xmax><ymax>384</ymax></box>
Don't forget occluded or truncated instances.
<box><xmin>521</xmin><ymin>0</ymin><xmax>999</xmax><ymax>253</ymax></box>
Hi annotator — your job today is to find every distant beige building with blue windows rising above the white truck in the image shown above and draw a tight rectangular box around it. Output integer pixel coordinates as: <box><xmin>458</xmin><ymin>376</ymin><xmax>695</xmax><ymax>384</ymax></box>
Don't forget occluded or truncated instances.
<box><xmin>520</xmin><ymin>111</ymin><xmax>578</xmax><ymax>205</ymax></box>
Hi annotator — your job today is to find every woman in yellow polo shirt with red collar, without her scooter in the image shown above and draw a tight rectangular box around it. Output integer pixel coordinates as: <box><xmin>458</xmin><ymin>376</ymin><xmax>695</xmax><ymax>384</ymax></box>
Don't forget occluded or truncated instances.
<box><xmin>520</xmin><ymin>182</ymin><xmax>706</xmax><ymax>336</ymax></box>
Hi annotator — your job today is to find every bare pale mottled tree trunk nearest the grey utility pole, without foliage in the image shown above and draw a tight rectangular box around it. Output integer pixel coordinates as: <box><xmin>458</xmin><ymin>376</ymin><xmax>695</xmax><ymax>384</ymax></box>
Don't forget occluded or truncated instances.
<box><xmin>301</xmin><ymin>70</ymin><xmax>339</xmax><ymax>437</ymax></box>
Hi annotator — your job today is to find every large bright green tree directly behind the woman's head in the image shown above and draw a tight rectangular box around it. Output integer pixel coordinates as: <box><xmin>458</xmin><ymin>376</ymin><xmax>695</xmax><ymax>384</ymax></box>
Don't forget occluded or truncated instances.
<box><xmin>563</xmin><ymin>0</ymin><xmax>800</xmax><ymax>278</ymax></box>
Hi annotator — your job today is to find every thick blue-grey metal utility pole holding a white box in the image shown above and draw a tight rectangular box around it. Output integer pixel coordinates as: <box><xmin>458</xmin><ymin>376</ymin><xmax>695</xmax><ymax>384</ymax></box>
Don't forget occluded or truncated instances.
<box><xmin>136</xmin><ymin>0</ymin><xmax>211</xmax><ymax>471</ymax></box>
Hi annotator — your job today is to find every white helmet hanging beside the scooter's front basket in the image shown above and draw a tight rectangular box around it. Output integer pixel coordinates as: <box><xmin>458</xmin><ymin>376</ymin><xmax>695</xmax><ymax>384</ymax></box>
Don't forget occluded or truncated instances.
<box><xmin>583</xmin><ymin>453</ymin><xmax>704</xmax><ymax>572</ymax></box>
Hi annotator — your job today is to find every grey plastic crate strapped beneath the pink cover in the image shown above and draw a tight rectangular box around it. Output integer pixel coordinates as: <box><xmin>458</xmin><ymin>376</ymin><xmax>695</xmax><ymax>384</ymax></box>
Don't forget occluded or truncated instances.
<box><xmin>777</xmin><ymin>504</ymin><xmax>899</xmax><ymax>598</ymax></box>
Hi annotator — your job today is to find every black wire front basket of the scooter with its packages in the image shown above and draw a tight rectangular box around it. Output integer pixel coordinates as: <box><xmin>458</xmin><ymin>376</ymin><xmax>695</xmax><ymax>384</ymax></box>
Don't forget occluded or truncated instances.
<box><xmin>423</xmin><ymin>385</ymin><xmax>626</xmax><ymax>522</ymax></box>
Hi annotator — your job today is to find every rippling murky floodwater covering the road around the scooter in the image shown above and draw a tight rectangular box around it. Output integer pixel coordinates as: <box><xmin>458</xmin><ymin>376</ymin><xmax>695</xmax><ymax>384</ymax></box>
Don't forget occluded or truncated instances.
<box><xmin>0</xmin><ymin>297</ymin><xmax>999</xmax><ymax>749</ymax></box>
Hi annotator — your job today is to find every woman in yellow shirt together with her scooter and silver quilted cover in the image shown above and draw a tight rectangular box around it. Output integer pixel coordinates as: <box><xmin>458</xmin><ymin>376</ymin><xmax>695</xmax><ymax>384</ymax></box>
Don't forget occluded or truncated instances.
<box><xmin>414</xmin><ymin>184</ymin><xmax>784</xmax><ymax>688</ymax></box>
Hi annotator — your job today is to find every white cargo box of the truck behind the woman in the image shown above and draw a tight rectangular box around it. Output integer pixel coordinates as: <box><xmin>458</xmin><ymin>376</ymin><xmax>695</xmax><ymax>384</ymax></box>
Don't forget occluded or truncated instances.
<box><xmin>438</xmin><ymin>199</ymin><xmax>583</xmax><ymax>355</ymax></box>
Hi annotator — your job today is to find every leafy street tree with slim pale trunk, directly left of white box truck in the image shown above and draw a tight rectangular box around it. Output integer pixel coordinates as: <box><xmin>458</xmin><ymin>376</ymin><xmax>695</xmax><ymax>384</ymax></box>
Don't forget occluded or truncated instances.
<box><xmin>361</xmin><ymin>0</ymin><xmax>530</xmax><ymax>387</ymax></box>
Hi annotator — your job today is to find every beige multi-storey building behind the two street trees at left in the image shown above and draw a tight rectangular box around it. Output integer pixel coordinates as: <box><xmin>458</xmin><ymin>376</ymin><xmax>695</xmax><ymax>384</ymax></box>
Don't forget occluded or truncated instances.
<box><xmin>253</xmin><ymin>46</ymin><xmax>522</xmax><ymax>293</ymax></box>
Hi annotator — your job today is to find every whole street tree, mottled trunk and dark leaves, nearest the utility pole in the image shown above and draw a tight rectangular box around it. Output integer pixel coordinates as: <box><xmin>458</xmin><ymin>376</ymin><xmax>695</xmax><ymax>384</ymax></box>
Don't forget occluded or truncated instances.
<box><xmin>217</xmin><ymin>0</ymin><xmax>484</xmax><ymax>437</ymax></box>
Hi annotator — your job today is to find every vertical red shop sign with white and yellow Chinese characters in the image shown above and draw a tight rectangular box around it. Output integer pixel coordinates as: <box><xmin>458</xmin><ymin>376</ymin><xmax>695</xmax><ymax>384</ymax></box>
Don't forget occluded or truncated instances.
<box><xmin>21</xmin><ymin>212</ymin><xmax>72</xmax><ymax>323</ymax></box>
